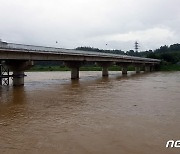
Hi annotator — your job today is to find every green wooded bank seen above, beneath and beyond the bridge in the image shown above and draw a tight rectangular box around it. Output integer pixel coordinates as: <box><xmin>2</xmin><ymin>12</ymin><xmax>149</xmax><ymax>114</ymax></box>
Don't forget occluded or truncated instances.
<box><xmin>31</xmin><ymin>43</ymin><xmax>180</xmax><ymax>71</ymax></box>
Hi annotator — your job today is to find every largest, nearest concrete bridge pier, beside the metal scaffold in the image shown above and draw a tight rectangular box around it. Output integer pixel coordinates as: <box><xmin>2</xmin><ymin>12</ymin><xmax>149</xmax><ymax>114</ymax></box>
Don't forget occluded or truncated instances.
<box><xmin>6</xmin><ymin>60</ymin><xmax>33</xmax><ymax>86</ymax></box>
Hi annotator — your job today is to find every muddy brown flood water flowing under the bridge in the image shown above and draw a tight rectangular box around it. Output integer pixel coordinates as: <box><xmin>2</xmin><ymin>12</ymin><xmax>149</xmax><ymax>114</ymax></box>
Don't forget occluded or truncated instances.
<box><xmin>0</xmin><ymin>72</ymin><xmax>180</xmax><ymax>154</ymax></box>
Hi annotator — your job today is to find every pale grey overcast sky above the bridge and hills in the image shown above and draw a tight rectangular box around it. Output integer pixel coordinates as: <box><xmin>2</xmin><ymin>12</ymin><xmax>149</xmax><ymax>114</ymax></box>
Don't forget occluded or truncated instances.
<box><xmin>0</xmin><ymin>0</ymin><xmax>180</xmax><ymax>51</ymax></box>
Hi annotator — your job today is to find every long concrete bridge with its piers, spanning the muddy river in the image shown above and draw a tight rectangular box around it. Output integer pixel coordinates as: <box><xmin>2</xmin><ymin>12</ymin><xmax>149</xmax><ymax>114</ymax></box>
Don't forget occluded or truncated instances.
<box><xmin>0</xmin><ymin>41</ymin><xmax>160</xmax><ymax>86</ymax></box>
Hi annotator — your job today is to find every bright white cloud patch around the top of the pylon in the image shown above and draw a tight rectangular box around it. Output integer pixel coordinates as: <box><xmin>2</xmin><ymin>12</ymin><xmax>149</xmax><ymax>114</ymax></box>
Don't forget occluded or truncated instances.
<box><xmin>94</xmin><ymin>28</ymin><xmax>175</xmax><ymax>50</ymax></box>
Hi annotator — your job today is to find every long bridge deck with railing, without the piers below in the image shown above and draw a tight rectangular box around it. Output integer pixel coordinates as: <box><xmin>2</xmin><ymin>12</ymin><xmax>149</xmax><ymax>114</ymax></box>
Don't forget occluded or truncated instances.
<box><xmin>0</xmin><ymin>42</ymin><xmax>160</xmax><ymax>63</ymax></box>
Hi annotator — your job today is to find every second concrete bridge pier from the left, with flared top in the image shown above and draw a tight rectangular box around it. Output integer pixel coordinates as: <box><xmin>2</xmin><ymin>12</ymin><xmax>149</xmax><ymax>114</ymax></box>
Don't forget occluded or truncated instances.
<box><xmin>64</xmin><ymin>61</ymin><xmax>82</xmax><ymax>79</ymax></box>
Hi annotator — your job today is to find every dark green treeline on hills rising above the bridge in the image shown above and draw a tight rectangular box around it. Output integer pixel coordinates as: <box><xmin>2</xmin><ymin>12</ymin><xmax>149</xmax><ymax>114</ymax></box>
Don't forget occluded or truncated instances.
<box><xmin>76</xmin><ymin>43</ymin><xmax>180</xmax><ymax>64</ymax></box>
